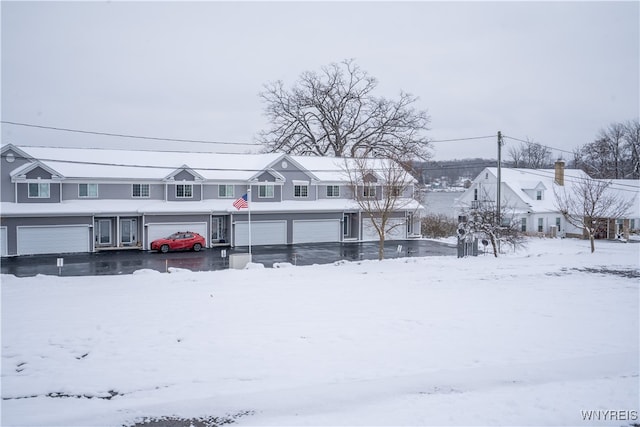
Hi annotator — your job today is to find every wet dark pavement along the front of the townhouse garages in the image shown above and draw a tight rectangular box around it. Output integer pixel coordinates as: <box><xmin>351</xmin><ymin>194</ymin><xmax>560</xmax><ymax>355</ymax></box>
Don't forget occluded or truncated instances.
<box><xmin>0</xmin><ymin>240</ymin><xmax>457</xmax><ymax>277</ymax></box>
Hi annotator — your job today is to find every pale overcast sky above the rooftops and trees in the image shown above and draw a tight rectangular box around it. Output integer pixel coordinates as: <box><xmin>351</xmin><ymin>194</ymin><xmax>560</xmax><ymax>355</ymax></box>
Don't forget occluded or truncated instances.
<box><xmin>1</xmin><ymin>1</ymin><xmax>640</xmax><ymax>160</ymax></box>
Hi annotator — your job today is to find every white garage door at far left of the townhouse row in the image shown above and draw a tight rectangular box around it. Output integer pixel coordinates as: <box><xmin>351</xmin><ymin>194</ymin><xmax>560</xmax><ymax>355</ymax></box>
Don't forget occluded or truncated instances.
<box><xmin>17</xmin><ymin>225</ymin><xmax>89</xmax><ymax>255</ymax></box>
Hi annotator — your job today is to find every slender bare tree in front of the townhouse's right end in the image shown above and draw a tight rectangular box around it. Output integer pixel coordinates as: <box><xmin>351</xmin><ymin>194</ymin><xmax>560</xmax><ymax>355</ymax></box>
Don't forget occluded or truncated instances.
<box><xmin>344</xmin><ymin>157</ymin><xmax>420</xmax><ymax>260</ymax></box>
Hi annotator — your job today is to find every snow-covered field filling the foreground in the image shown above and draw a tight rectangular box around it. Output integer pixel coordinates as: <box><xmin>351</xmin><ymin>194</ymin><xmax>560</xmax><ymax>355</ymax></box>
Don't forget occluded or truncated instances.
<box><xmin>2</xmin><ymin>239</ymin><xmax>640</xmax><ymax>426</ymax></box>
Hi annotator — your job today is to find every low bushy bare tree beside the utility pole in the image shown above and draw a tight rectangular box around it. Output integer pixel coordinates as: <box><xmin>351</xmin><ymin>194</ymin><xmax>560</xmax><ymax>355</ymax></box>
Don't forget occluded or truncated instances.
<box><xmin>458</xmin><ymin>200</ymin><xmax>524</xmax><ymax>258</ymax></box>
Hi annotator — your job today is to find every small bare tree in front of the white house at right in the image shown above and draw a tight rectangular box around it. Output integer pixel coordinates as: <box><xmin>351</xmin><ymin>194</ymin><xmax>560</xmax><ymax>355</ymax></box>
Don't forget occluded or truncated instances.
<box><xmin>553</xmin><ymin>177</ymin><xmax>635</xmax><ymax>253</ymax></box>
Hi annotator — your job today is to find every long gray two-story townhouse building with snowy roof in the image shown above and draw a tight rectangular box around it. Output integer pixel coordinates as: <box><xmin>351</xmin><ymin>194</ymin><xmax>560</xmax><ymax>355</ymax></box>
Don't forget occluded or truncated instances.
<box><xmin>0</xmin><ymin>144</ymin><xmax>424</xmax><ymax>256</ymax></box>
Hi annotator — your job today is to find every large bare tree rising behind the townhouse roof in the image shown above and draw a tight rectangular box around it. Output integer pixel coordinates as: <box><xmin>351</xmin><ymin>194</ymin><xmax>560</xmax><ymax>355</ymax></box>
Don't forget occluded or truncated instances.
<box><xmin>258</xmin><ymin>60</ymin><xmax>430</xmax><ymax>159</ymax></box>
